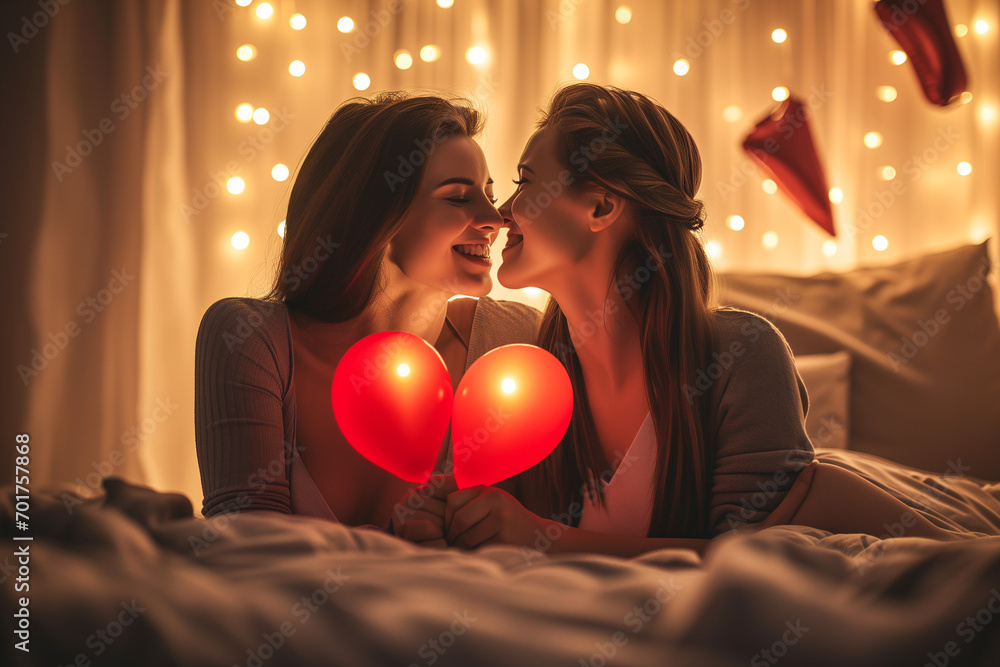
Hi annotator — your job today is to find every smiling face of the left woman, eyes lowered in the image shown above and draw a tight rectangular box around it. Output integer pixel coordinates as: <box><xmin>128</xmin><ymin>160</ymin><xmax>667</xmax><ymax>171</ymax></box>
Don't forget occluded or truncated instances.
<box><xmin>389</xmin><ymin>136</ymin><xmax>503</xmax><ymax>296</ymax></box>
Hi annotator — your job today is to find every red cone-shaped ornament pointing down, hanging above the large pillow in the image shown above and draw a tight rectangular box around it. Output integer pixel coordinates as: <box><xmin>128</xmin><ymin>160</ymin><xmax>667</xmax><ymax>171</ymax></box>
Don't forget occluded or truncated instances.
<box><xmin>743</xmin><ymin>96</ymin><xmax>837</xmax><ymax>236</ymax></box>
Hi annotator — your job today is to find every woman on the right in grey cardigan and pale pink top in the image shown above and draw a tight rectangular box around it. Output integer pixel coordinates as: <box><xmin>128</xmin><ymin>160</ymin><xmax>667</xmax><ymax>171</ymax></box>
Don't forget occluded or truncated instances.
<box><xmin>428</xmin><ymin>83</ymin><xmax>968</xmax><ymax>556</ymax></box>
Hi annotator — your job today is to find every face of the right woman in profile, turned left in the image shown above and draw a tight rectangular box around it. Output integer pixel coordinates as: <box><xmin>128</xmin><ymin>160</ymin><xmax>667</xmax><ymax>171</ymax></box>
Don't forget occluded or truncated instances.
<box><xmin>497</xmin><ymin>128</ymin><xmax>595</xmax><ymax>291</ymax></box>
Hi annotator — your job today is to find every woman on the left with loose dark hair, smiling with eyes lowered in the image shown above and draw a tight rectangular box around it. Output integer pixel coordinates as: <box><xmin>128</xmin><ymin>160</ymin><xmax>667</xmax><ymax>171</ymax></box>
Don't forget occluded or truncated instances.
<box><xmin>195</xmin><ymin>93</ymin><xmax>539</xmax><ymax>541</ymax></box>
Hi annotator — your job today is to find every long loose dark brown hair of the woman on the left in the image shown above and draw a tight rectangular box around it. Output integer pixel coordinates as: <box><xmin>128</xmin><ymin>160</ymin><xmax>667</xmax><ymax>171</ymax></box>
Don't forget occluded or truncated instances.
<box><xmin>263</xmin><ymin>92</ymin><xmax>483</xmax><ymax>322</ymax></box>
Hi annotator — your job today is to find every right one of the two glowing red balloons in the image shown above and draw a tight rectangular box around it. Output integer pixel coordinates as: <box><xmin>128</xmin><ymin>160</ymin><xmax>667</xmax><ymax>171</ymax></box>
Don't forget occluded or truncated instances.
<box><xmin>451</xmin><ymin>344</ymin><xmax>573</xmax><ymax>489</ymax></box>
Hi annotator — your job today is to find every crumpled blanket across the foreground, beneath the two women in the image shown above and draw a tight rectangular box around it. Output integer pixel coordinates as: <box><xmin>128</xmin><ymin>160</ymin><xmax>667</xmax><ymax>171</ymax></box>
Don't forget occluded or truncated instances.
<box><xmin>0</xmin><ymin>479</ymin><xmax>1000</xmax><ymax>667</ymax></box>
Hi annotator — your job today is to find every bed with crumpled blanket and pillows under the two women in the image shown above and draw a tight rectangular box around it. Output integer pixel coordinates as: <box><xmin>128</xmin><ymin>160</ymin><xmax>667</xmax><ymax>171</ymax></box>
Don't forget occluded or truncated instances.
<box><xmin>0</xmin><ymin>245</ymin><xmax>1000</xmax><ymax>667</ymax></box>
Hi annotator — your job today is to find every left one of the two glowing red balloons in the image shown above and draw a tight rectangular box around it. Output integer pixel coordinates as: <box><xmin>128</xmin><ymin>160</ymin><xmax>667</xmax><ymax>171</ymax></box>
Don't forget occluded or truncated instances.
<box><xmin>330</xmin><ymin>331</ymin><xmax>452</xmax><ymax>483</ymax></box>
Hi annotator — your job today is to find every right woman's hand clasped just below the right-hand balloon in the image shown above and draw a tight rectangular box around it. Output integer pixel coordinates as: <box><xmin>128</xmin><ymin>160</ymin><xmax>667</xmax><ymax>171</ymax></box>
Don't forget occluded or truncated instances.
<box><xmin>444</xmin><ymin>485</ymin><xmax>547</xmax><ymax>549</ymax></box>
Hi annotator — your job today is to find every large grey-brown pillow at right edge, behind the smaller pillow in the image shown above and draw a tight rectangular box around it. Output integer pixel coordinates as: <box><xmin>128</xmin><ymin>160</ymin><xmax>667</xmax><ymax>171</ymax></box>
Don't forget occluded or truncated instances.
<box><xmin>719</xmin><ymin>241</ymin><xmax>1000</xmax><ymax>480</ymax></box>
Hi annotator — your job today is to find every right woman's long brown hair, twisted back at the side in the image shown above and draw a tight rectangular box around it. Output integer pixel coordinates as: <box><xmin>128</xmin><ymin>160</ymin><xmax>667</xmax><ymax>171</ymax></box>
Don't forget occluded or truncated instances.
<box><xmin>516</xmin><ymin>83</ymin><xmax>715</xmax><ymax>537</ymax></box>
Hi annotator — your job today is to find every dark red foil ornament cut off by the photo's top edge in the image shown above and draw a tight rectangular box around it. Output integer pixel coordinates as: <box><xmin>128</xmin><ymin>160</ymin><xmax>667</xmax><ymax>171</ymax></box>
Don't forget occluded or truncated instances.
<box><xmin>875</xmin><ymin>0</ymin><xmax>968</xmax><ymax>107</ymax></box>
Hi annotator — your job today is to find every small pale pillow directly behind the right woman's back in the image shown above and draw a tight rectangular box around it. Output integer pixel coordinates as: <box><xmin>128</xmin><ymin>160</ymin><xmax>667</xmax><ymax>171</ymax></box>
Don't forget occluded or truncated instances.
<box><xmin>795</xmin><ymin>350</ymin><xmax>851</xmax><ymax>449</ymax></box>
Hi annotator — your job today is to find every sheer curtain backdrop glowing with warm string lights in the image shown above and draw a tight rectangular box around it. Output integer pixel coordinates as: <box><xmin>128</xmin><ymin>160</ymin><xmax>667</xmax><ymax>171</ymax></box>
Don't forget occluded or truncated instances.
<box><xmin>0</xmin><ymin>0</ymin><xmax>1000</xmax><ymax>507</ymax></box>
